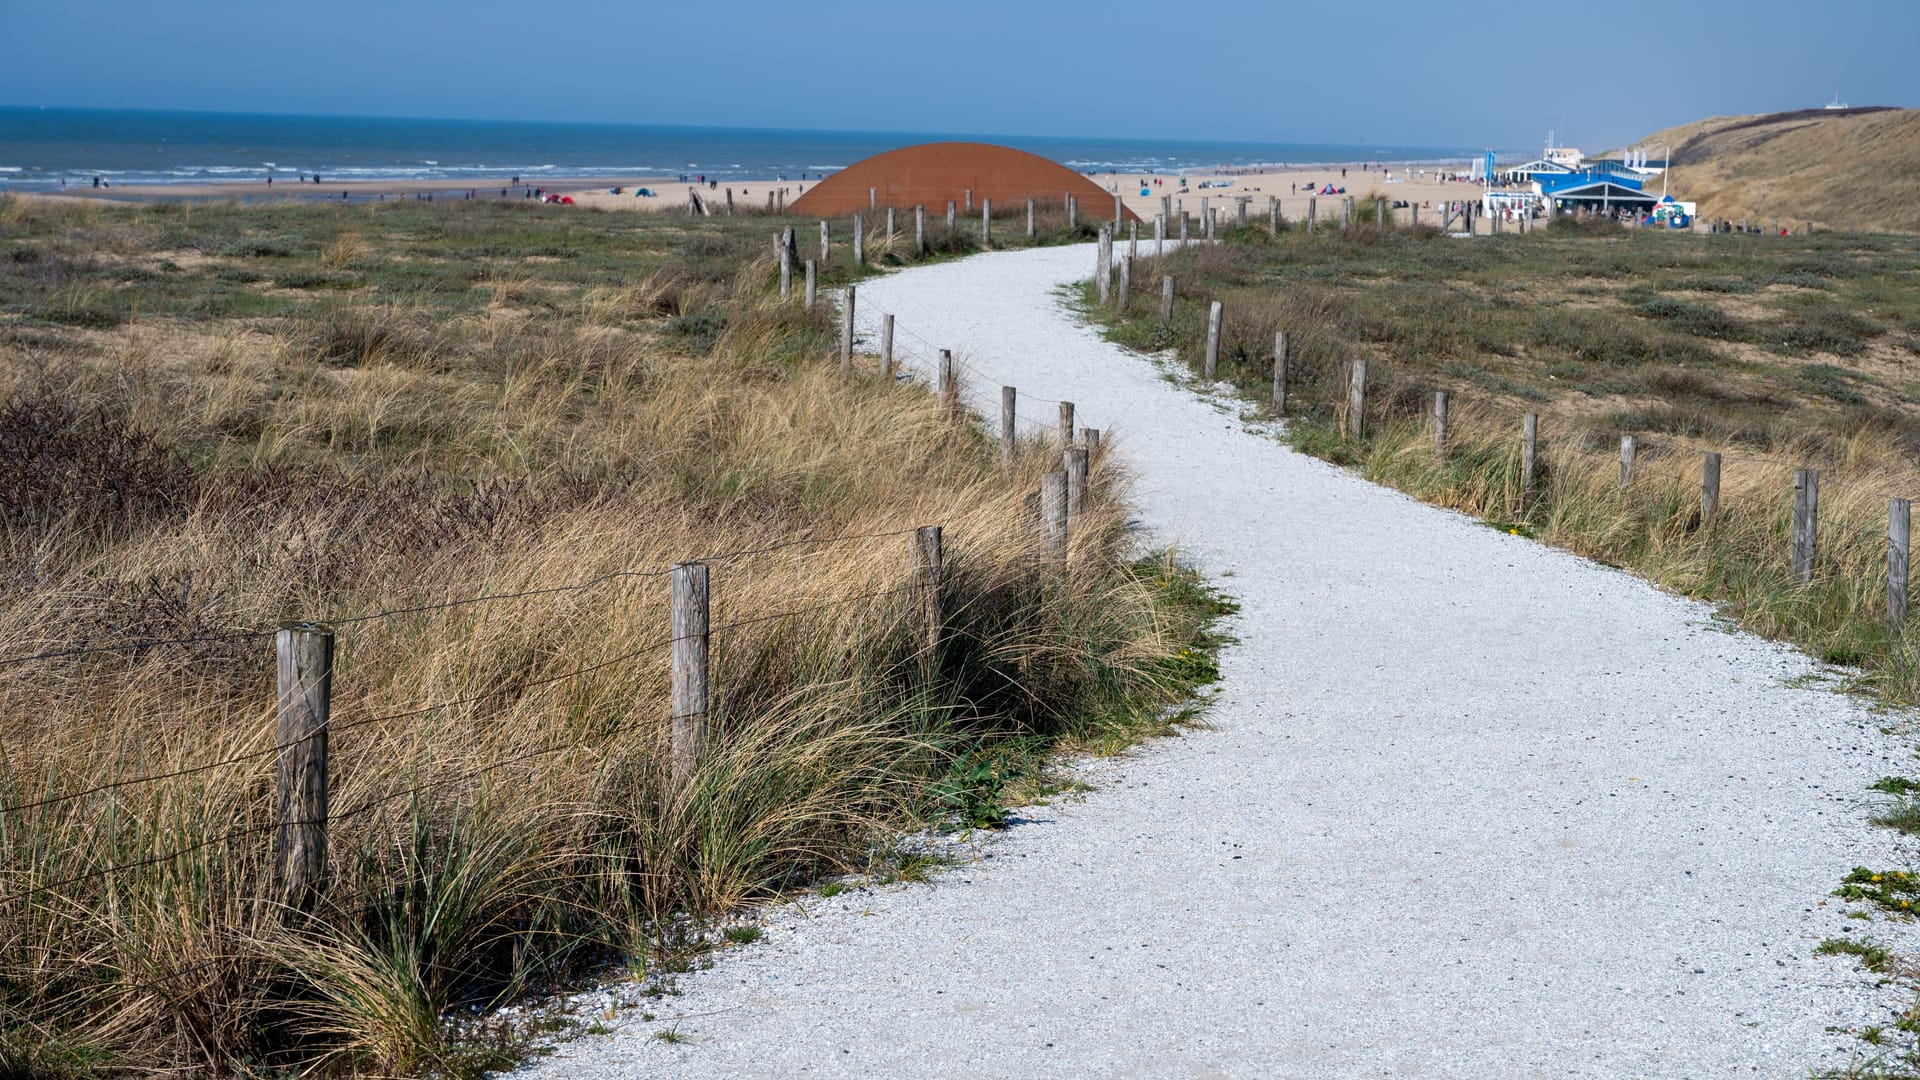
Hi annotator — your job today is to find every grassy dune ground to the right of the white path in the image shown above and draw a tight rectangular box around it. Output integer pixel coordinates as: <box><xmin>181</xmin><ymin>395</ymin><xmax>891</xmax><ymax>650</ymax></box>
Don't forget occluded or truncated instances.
<box><xmin>1102</xmin><ymin>208</ymin><xmax>1920</xmax><ymax>691</ymax></box>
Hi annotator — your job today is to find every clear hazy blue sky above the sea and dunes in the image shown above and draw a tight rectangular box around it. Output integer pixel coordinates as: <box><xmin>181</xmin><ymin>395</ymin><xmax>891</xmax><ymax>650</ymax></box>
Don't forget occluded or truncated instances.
<box><xmin>0</xmin><ymin>0</ymin><xmax>1920</xmax><ymax>150</ymax></box>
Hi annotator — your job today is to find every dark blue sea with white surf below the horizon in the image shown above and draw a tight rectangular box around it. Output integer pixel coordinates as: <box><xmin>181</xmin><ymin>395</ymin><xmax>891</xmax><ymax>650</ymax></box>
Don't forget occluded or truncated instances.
<box><xmin>0</xmin><ymin>108</ymin><xmax>1484</xmax><ymax>190</ymax></box>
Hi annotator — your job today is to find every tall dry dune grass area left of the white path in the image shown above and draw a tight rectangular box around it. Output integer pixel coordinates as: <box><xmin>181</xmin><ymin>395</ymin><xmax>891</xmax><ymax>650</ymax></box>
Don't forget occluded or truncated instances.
<box><xmin>0</xmin><ymin>200</ymin><xmax>1215</xmax><ymax>1076</ymax></box>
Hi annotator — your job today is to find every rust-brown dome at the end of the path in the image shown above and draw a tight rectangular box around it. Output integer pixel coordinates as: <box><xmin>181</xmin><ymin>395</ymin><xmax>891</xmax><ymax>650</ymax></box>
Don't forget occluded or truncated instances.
<box><xmin>787</xmin><ymin>142</ymin><xmax>1140</xmax><ymax>221</ymax></box>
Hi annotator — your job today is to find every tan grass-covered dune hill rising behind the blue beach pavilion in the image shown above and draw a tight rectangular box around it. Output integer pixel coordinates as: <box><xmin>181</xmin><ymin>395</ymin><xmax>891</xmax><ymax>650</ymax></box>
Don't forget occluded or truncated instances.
<box><xmin>1640</xmin><ymin>108</ymin><xmax>1920</xmax><ymax>233</ymax></box>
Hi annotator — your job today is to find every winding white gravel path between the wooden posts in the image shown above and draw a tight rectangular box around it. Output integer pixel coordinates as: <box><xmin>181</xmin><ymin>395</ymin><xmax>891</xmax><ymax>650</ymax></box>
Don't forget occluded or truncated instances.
<box><xmin>526</xmin><ymin>246</ymin><xmax>1912</xmax><ymax>1078</ymax></box>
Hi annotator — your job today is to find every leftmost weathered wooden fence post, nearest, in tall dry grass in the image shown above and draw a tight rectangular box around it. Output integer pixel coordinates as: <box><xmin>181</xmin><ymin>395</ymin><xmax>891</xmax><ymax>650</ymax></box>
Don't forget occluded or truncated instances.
<box><xmin>273</xmin><ymin>623</ymin><xmax>334</xmax><ymax>911</ymax></box>
